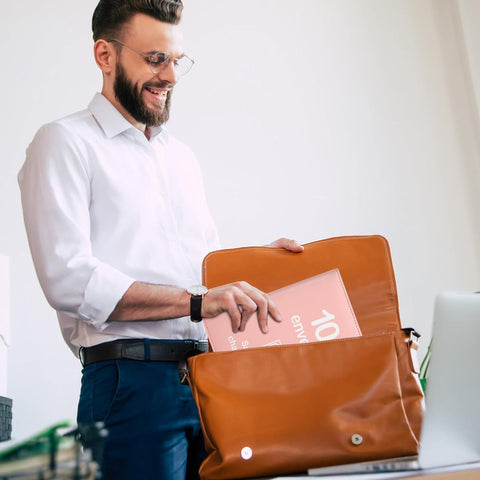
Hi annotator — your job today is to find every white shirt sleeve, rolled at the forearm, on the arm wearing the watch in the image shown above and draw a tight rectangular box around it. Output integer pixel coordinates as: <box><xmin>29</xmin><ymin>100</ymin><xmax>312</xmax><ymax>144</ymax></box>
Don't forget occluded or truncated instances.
<box><xmin>18</xmin><ymin>123</ymin><xmax>134</xmax><ymax>330</ymax></box>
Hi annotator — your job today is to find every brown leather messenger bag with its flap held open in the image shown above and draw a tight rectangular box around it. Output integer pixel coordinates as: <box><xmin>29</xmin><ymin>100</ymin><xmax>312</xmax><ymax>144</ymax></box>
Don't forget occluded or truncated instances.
<box><xmin>188</xmin><ymin>236</ymin><xmax>423</xmax><ymax>480</ymax></box>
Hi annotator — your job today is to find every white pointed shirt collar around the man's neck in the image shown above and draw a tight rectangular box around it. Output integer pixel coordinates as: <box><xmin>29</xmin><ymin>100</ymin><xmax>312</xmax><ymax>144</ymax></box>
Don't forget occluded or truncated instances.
<box><xmin>88</xmin><ymin>93</ymin><xmax>168</xmax><ymax>142</ymax></box>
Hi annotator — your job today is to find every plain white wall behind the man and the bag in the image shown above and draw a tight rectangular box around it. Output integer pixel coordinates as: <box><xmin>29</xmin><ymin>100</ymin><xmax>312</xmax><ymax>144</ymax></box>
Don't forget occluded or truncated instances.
<box><xmin>0</xmin><ymin>0</ymin><xmax>480</xmax><ymax>437</ymax></box>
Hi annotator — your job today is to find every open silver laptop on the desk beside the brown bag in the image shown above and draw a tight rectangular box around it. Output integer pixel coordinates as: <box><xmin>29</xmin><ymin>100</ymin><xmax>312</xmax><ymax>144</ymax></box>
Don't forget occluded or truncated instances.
<box><xmin>308</xmin><ymin>292</ymin><xmax>480</xmax><ymax>476</ymax></box>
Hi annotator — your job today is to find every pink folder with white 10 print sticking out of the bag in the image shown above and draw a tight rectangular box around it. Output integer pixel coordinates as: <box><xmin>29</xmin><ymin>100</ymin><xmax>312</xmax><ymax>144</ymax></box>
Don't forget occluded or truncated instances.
<box><xmin>204</xmin><ymin>269</ymin><xmax>361</xmax><ymax>351</ymax></box>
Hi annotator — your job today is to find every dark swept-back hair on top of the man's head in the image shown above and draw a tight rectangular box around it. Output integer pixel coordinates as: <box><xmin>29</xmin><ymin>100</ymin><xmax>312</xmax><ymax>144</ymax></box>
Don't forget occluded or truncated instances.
<box><xmin>92</xmin><ymin>0</ymin><xmax>183</xmax><ymax>42</ymax></box>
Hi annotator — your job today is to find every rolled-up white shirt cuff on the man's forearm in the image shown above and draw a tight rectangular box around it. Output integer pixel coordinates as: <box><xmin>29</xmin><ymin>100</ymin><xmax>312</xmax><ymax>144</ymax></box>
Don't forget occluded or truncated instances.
<box><xmin>79</xmin><ymin>264</ymin><xmax>135</xmax><ymax>331</ymax></box>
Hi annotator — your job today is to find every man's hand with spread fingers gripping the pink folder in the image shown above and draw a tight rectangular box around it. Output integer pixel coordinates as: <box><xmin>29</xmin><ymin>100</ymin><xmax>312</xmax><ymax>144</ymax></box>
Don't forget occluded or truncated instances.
<box><xmin>202</xmin><ymin>282</ymin><xmax>282</xmax><ymax>333</ymax></box>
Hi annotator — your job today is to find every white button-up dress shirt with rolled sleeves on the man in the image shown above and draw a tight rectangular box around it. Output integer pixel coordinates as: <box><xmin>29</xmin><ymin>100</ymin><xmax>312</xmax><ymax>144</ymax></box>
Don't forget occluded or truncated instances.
<box><xmin>18</xmin><ymin>94</ymin><xmax>219</xmax><ymax>355</ymax></box>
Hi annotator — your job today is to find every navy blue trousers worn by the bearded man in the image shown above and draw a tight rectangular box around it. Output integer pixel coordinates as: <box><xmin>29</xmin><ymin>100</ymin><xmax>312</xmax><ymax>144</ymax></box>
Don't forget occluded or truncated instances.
<box><xmin>77</xmin><ymin>360</ymin><xmax>206</xmax><ymax>480</ymax></box>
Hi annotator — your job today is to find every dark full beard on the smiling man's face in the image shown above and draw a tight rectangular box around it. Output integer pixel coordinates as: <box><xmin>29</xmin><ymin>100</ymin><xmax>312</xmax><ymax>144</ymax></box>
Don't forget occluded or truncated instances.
<box><xmin>113</xmin><ymin>63</ymin><xmax>172</xmax><ymax>127</ymax></box>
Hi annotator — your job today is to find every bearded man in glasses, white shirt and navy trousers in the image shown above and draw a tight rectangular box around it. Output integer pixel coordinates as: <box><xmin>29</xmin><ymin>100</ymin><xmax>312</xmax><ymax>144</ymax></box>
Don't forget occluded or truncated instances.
<box><xmin>18</xmin><ymin>0</ymin><xmax>302</xmax><ymax>480</ymax></box>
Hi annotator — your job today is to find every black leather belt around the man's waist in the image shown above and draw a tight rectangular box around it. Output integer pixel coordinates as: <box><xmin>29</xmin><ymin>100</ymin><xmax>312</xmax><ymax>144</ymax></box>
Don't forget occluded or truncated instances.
<box><xmin>79</xmin><ymin>338</ymin><xmax>208</xmax><ymax>383</ymax></box>
